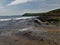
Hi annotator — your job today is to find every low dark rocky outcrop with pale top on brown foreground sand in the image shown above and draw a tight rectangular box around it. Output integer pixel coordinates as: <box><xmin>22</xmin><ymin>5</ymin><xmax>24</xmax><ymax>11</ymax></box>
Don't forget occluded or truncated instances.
<box><xmin>16</xmin><ymin>29</ymin><xmax>60</xmax><ymax>43</ymax></box>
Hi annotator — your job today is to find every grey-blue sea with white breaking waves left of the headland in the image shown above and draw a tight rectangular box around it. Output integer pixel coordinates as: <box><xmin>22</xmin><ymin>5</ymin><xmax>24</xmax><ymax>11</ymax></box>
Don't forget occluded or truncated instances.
<box><xmin>0</xmin><ymin>16</ymin><xmax>36</xmax><ymax>30</ymax></box>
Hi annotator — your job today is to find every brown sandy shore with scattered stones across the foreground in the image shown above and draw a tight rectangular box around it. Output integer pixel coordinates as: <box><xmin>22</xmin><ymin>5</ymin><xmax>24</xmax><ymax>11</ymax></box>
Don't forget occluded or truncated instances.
<box><xmin>0</xmin><ymin>27</ymin><xmax>60</xmax><ymax>45</ymax></box>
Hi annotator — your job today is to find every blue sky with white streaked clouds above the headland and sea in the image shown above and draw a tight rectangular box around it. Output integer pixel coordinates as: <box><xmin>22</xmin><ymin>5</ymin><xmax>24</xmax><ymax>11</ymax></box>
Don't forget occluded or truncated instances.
<box><xmin>0</xmin><ymin>0</ymin><xmax>60</xmax><ymax>16</ymax></box>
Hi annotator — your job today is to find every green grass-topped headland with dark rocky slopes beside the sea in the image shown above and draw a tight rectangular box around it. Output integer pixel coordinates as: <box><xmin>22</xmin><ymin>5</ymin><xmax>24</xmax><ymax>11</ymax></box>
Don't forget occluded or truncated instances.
<box><xmin>23</xmin><ymin>9</ymin><xmax>60</xmax><ymax>26</ymax></box>
